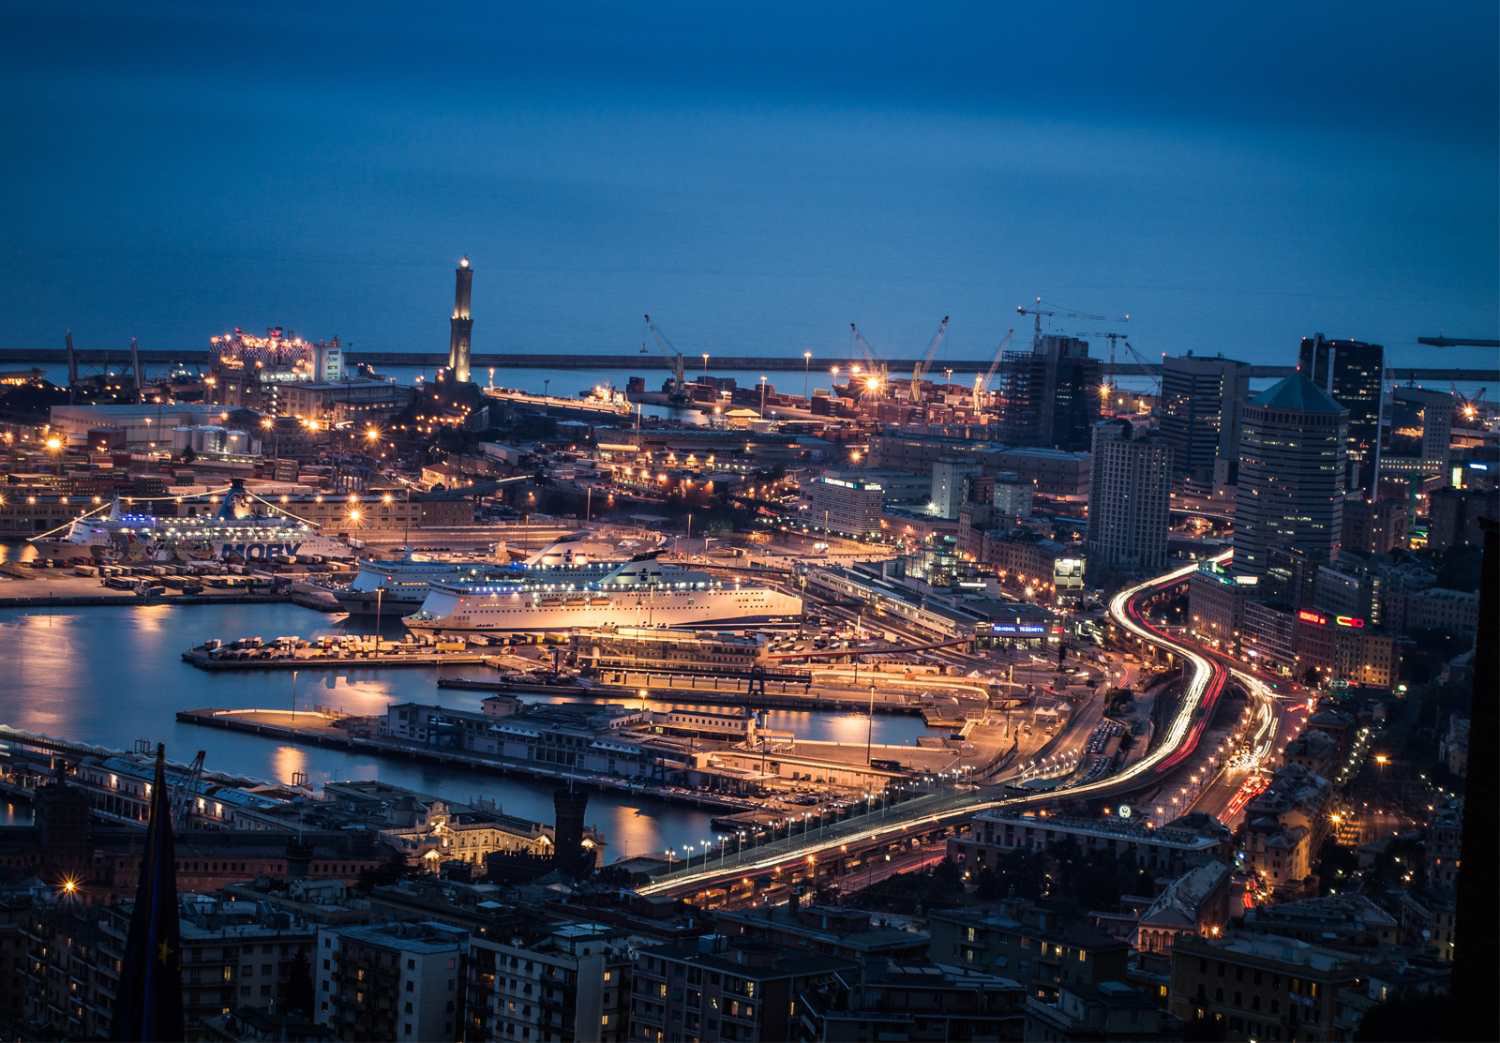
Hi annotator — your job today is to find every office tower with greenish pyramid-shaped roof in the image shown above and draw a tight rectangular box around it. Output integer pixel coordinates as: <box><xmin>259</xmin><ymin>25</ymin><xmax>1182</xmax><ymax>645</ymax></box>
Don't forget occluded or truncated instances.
<box><xmin>1235</xmin><ymin>372</ymin><xmax>1349</xmax><ymax>579</ymax></box>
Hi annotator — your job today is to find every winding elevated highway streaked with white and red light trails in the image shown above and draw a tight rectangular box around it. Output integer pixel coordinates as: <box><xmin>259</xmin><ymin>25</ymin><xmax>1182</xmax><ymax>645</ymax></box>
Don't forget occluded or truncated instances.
<box><xmin>638</xmin><ymin>552</ymin><xmax>1236</xmax><ymax>894</ymax></box>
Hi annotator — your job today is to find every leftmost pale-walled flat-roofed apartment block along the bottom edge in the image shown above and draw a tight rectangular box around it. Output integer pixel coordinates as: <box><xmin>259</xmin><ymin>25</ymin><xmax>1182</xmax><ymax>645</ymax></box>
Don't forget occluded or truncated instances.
<box><xmin>314</xmin><ymin>921</ymin><xmax>468</xmax><ymax>1043</ymax></box>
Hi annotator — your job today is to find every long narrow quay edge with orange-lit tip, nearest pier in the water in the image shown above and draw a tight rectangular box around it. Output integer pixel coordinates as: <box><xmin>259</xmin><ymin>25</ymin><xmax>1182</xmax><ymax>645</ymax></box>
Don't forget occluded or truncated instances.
<box><xmin>177</xmin><ymin>707</ymin><xmax>759</xmax><ymax>812</ymax></box>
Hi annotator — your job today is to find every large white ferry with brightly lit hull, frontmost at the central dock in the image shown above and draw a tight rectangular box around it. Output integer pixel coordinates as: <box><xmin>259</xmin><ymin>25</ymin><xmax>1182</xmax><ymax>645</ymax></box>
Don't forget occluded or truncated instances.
<box><xmin>402</xmin><ymin>558</ymin><xmax>803</xmax><ymax>633</ymax></box>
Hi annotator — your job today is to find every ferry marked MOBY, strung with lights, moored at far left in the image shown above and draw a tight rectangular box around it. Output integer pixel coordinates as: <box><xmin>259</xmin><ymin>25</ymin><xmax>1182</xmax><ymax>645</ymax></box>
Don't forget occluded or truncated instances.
<box><xmin>32</xmin><ymin>479</ymin><xmax>356</xmax><ymax>561</ymax></box>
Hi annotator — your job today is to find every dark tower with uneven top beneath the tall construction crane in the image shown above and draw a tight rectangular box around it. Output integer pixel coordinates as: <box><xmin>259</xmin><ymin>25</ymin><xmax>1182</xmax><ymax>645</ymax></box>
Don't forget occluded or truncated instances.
<box><xmin>1001</xmin><ymin>335</ymin><xmax>1101</xmax><ymax>450</ymax></box>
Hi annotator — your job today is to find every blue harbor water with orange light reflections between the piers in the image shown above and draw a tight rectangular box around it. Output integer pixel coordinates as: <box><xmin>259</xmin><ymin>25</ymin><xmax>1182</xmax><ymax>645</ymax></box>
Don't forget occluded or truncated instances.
<box><xmin>0</xmin><ymin>600</ymin><xmax>926</xmax><ymax>860</ymax></box>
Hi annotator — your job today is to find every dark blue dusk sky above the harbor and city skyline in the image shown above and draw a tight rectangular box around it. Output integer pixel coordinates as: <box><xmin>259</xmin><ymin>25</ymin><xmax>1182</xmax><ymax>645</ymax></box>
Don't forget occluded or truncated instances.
<box><xmin>0</xmin><ymin>0</ymin><xmax>1500</xmax><ymax>365</ymax></box>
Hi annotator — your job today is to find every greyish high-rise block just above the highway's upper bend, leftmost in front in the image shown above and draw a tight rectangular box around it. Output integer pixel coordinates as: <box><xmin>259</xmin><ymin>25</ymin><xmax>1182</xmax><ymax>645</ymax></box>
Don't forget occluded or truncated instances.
<box><xmin>1088</xmin><ymin>420</ymin><xmax>1172</xmax><ymax>582</ymax></box>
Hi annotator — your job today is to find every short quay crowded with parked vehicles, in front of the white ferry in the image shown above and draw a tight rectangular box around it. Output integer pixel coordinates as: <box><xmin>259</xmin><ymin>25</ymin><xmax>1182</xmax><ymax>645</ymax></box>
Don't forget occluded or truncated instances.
<box><xmin>183</xmin><ymin>635</ymin><xmax>494</xmax><ymax>671</ymax></box>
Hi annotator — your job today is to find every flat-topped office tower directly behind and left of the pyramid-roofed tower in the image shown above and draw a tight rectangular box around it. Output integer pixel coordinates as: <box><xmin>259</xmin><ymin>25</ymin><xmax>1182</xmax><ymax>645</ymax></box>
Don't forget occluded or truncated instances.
<box><xmin>1161</xmin><ymin>351</ymin><xmax>1250</xmax><ymax>488</ymax></box>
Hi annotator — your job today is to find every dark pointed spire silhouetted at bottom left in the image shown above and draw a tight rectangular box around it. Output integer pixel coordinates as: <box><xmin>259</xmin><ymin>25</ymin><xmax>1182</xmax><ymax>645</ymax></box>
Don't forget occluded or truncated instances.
<box><xmin>113</xmin><ymin>744</ymin><xmax>183</xmax><ymax>1043</ymax></box>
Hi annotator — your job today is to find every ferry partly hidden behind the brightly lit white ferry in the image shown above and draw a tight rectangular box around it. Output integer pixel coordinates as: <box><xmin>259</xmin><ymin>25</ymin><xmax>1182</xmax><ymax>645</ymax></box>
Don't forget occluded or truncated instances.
<box><xmin>329</xmin><ymin>534</ymin><xmax>657</xmax><ymax>617</ymax></box>
